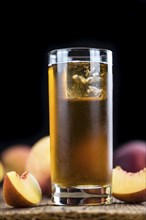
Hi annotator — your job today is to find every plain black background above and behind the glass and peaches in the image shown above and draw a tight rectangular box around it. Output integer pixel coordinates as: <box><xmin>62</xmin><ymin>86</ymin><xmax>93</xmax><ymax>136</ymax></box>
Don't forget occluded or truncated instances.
<box><xmin>0</xmin><ymin>1</ymin><xmax>146</xmax><ymax>150</ymax></box>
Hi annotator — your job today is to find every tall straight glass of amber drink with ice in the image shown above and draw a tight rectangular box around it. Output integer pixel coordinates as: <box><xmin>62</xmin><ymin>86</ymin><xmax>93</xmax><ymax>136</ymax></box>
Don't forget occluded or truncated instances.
<box><xmin>48</xmin><ymin>48</ymin><xmax>112</xmax><ymax>205</ymax></box>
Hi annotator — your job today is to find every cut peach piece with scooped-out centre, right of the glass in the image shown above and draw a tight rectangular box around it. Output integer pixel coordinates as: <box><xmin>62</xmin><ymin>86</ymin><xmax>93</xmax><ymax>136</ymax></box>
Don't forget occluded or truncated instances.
<box><xmin>112</xmin><ymin>166</ymin><xmax>146</xmax><ymax>203</ymax></box>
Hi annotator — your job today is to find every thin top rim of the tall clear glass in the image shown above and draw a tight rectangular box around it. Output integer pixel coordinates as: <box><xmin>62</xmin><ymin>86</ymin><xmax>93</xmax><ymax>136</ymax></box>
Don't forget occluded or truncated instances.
<box><xmin>48</xmin><ymin>47</ymin><xmax>112</xmax><ymax>55</ymax></box>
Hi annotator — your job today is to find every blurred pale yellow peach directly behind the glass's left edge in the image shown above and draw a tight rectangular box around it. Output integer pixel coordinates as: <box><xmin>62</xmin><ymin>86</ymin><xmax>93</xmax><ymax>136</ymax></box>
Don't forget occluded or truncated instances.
<box><xmin>26</xmin><ymin>136</ymin><xmax>51</xmax><ymax>196</ymax></box>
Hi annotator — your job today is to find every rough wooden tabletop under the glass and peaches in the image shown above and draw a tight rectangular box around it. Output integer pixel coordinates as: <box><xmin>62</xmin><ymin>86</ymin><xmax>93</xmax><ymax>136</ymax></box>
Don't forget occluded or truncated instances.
<box><xmin>0</xmin><ymin>195</ymin><xmax>146</xmax><ymax>220</ymax></box>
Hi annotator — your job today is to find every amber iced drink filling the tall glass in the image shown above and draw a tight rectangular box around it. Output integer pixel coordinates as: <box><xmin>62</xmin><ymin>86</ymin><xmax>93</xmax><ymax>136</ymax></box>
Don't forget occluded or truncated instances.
<box><xmin>49</xmin><ymin>62</ymin><xmax>111</xmax><ymax>187</ymax></box>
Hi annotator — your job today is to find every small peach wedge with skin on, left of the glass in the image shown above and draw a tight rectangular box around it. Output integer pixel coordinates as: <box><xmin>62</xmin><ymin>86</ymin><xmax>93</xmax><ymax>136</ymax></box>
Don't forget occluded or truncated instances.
<box><xmin>3</xmin><ymin>171</ymin><xmax>42</xmax><ymax>207</ymax></box>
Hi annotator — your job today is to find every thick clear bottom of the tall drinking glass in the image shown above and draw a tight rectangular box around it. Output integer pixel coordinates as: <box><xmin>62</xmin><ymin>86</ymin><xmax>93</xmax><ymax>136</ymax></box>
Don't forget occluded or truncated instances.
<box><xmin>52</xmin><ymin>184</ymin><xmax>112</xmax><ymax>205</ymax></box>
